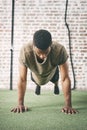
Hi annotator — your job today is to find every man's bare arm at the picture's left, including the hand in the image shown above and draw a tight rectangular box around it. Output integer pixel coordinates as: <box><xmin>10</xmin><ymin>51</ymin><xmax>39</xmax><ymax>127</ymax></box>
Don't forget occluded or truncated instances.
<box><xmin>11</xmin><ymin>64</ymin><xmax>28</xmax><ymax>113</ymax></box>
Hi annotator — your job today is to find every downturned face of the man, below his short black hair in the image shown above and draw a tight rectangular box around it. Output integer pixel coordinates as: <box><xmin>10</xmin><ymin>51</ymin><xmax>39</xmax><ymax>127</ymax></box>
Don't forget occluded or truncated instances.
<box><xmin>33</xmin><ymin>46</ymin><xmax>51</xmax><ymax>60</ymax></box>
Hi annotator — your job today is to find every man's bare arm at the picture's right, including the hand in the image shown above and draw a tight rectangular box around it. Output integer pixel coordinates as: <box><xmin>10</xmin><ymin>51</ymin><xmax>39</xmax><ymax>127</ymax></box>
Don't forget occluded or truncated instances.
<box><xmin>59</xmin><ymin>62</ymin><xmax>76</xmax><ymax>114</ymax></box>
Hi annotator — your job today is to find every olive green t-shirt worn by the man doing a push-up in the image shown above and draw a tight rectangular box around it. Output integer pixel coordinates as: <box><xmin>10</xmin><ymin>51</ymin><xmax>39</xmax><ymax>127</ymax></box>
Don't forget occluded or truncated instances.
<box><xmin>19</xmin><ymin>42</ymin><xmax>68</xmax><ymax>85</ymax></box>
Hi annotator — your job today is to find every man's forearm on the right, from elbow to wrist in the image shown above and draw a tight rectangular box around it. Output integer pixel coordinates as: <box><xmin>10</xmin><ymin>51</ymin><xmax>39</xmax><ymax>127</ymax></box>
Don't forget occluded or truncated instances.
<box><xmin>62</xmin><ymin>77</ymin><xmax>72</xmax><ymax>107</ymax></box>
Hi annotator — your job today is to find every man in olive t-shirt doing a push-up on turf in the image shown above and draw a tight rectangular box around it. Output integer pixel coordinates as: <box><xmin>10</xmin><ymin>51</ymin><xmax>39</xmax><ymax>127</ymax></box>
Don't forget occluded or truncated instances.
<box><xmin>11</xmin><ymin>30</ymin><xmax>77</xmax><ymax>114</ymax></box>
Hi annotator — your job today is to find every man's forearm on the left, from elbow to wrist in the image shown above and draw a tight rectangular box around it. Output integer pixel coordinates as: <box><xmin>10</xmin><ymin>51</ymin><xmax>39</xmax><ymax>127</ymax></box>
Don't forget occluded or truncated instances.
<box><xmin>18</xmin><ymin>81</ymin><xmax>26</xmax><ymax>105</ymax></box>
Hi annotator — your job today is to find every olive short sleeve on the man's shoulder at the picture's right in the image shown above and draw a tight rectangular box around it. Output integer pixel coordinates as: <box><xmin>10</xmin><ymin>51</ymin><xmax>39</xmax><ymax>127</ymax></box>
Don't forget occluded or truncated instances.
<box><xmin>59</xmin><ymin>46</ymin><xmax>69</xmax><ymax>65</ymax></box>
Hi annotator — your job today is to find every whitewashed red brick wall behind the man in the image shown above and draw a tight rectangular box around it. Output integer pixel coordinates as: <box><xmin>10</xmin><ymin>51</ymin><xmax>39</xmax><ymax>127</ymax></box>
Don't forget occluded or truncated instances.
<box><xmin>0</xmin><ymin>0</ymin><xmax>87</xmax><ymax>90</ymax></box>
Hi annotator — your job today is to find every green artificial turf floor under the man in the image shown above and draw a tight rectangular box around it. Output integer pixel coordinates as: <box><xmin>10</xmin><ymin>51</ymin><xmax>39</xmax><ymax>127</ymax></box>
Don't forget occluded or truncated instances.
<box><xmin>0</xmin><ymin>90</ymin><xmax>87</xmax><ymax>130</ymax></box>
